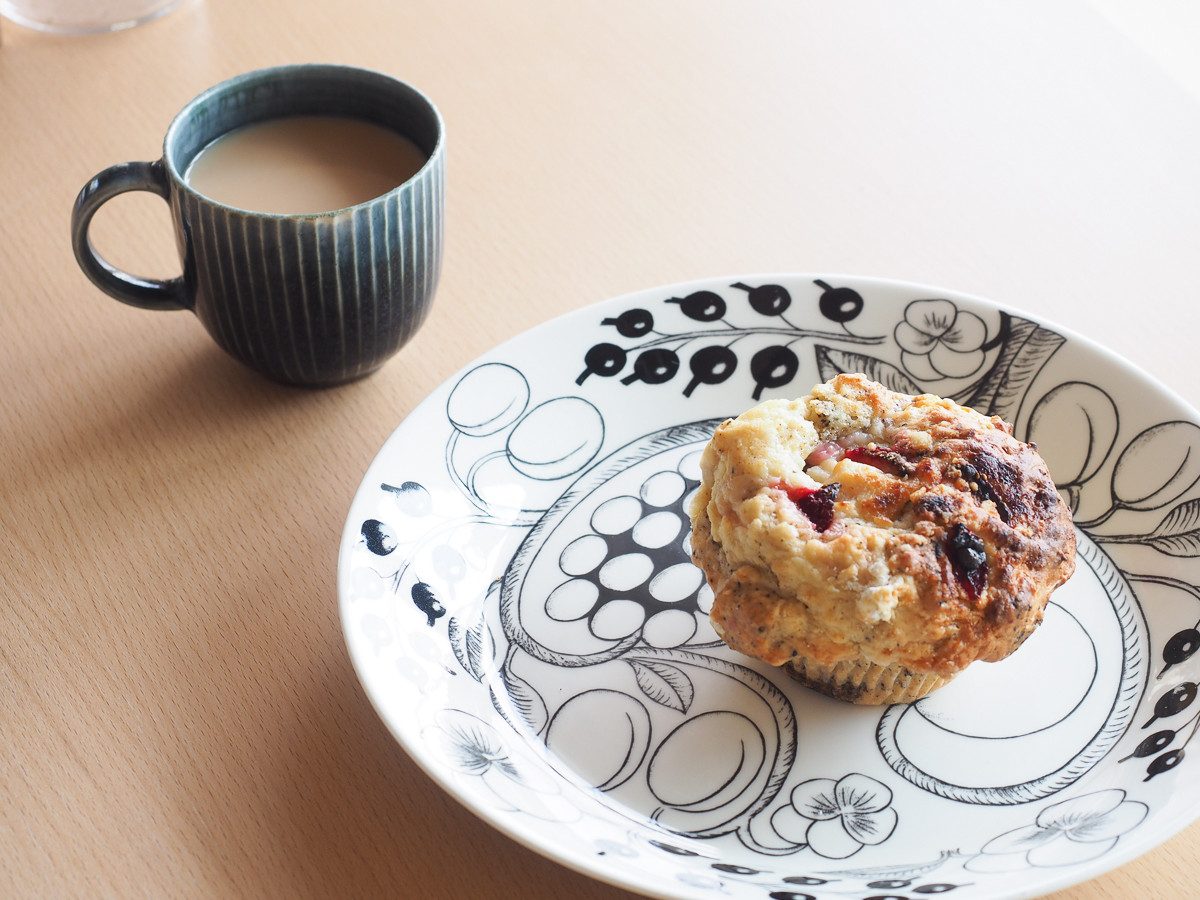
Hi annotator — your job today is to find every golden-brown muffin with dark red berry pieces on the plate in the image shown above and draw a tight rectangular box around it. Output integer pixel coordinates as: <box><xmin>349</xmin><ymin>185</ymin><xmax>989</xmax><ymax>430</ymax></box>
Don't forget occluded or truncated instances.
<box><xmin>689</xmin><ymin>374</ymin><xmax>1075</xmax><ymax>704</ymax></box>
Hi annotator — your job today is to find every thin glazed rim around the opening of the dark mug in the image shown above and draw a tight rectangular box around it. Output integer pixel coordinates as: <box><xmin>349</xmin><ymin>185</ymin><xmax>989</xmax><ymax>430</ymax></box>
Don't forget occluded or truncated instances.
<box><xmin>162</xmin><ymin>62</ymin><xmax>446</xmax><ymax>220</ymax></box>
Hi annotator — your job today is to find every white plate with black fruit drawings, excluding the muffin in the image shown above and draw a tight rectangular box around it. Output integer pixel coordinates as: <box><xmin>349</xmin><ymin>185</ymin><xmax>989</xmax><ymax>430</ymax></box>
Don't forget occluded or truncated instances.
<box><xmin>338</xmin><ymin>275</ymin><xmax>1200</xmax><ymax>900</ymax></box>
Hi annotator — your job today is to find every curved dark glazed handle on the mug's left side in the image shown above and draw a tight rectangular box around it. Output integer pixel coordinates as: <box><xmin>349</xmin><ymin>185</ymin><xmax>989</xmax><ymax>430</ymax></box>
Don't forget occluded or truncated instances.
<box><xmin>71</xmin><ymin>160</ymin><xmax>192</xmax><ymax>310</ymax></box>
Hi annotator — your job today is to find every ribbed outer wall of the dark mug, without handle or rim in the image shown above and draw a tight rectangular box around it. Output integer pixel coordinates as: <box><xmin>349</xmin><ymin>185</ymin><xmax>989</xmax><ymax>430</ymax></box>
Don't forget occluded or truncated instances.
<box><xmin>178</xmin><ymin>146</ymin><xmax>443</xmax><ymax>385</ymax></box>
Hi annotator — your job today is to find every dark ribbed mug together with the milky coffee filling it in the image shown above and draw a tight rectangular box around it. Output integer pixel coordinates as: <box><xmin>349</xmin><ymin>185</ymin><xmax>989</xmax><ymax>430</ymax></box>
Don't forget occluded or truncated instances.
<box><xmin>71</xmin><ymin>65</ymin><xmax>445</xmax><ymax>386</ymax></box>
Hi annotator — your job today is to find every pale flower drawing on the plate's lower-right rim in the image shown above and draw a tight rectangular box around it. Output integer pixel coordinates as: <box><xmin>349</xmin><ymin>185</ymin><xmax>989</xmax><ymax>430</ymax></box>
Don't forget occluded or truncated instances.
<box><xmin>966</xmin><ymin>788</ymin><xmax>1148</xmax><ymax>872</ymax></box>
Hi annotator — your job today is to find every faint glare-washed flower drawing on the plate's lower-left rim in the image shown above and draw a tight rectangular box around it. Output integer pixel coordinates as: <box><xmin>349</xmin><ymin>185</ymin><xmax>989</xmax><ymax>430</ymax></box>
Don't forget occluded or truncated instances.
<box><xmin>425</xmin><ymin>709</ymin><xmax>580</xmax><ymax>822</ymax></box>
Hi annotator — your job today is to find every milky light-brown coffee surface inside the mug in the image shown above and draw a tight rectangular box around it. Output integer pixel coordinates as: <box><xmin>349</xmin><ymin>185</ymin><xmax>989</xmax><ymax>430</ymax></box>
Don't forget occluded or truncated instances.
<box><xmin>184</xmin><ymin>115</ymin><xmax>428</xmax><ymax>215</ymax></box>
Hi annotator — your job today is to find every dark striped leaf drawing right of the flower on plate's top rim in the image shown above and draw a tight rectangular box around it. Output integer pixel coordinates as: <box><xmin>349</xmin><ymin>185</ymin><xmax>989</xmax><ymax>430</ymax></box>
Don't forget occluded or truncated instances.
<box><xmin>954</xmin><ymin>312</ymin><xmax>1067</xmax><ymax>422</ymax></box>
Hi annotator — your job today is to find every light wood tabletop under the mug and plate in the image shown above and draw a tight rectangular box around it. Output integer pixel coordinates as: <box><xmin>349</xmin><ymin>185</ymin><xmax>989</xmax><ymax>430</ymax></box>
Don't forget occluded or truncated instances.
<box><xmin>0</xmin><ymin>0</ymin><xmax>1200</xmax><ymax>900</ymax></box>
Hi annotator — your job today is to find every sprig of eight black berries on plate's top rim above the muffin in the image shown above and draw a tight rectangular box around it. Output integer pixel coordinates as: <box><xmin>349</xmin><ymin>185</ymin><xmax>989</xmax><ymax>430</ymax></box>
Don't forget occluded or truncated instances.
<box><xmin>575</xmin><ymin>281</ymin><xmax>886</xmax><ymax>400</ymax></box>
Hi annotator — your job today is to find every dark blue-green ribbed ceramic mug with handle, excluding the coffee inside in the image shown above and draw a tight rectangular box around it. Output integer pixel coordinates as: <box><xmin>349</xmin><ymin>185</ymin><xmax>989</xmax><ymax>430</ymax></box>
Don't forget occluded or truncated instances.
<box><xmin>71</xmin><ymin>65</ymin><xmax>445</xmax><ymax>386</ymax></box>
